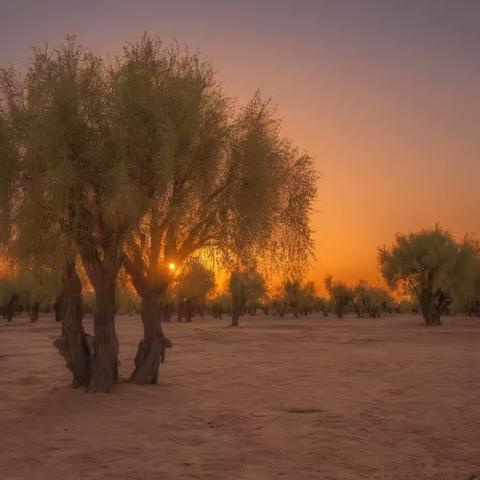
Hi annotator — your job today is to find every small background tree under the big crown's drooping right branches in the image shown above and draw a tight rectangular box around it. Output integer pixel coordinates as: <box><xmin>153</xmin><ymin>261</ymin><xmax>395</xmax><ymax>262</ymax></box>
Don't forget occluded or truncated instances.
<box><xmin>229</xmin><ymin>268</ymin><xmax>266</xmax><ymax>327</ymax></box>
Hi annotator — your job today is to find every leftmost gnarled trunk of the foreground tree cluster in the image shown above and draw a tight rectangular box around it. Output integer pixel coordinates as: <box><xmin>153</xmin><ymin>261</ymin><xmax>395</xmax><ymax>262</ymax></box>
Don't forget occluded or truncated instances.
<box><xmin>53</xmin><ymin>262</ymin><xmax>94</xmax><ymax>388</ymax></box>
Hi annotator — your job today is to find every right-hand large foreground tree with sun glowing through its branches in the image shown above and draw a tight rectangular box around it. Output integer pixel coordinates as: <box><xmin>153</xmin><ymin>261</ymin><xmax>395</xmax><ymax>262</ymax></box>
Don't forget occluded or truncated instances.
<box><xmin>119</xmin><ymin>37</ymin><xmax>317</xmax><ymax>383</ymax></box>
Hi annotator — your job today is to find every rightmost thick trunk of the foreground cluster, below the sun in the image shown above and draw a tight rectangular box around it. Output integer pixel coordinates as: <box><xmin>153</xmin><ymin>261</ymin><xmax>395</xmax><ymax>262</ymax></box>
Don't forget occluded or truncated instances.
<box><xmin>130</xmin><ymin>290</ymin><xmax>172</xmax><ymax>385</ymax></box>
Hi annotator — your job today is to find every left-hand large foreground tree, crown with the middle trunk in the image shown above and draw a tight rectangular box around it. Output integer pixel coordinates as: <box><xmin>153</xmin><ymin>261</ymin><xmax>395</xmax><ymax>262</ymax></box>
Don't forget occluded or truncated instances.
<box><xmin>0</xmin><ymin>38</ymin><xmax>153</xmax><ymax>391</ymax></box>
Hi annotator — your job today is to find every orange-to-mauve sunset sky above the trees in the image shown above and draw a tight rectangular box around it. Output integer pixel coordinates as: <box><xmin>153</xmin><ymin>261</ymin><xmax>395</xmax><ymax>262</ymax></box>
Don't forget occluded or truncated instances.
<box><xmin>0</xmin><ymin>0</ymin><xmax>480</xmax><ymax>283</ymax></box>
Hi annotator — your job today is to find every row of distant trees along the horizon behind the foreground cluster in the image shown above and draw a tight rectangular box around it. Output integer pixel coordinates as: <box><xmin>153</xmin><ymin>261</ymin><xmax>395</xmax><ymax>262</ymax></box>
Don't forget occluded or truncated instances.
<box><xmin>0</xmin><ymin>226</ymin><xmax>480</xmax><ymax>326</ymax></box>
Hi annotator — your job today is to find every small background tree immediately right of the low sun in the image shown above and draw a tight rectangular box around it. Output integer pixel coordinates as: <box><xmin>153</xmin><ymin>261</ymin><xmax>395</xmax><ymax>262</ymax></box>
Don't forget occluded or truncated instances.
<box><xmin>177</xmin><ymin>259</ymin><xmax>215</xmax><ymax>322</ymax></box>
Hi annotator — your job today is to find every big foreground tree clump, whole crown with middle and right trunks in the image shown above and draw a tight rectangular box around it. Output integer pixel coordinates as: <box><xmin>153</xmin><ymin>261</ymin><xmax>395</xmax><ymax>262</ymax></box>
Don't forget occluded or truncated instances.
<box><xmin>0</xmin><ymin>36</ymin><xmax>317</xmax><ymax>391</ymax></box>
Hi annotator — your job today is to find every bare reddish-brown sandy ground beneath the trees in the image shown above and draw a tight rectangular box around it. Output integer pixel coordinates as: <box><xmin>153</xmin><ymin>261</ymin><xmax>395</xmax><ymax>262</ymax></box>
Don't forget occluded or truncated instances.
<box><xmin>0</xmin><ymin>316</ymin><xmax>480</xmax><ymax>480</ymax></box>
